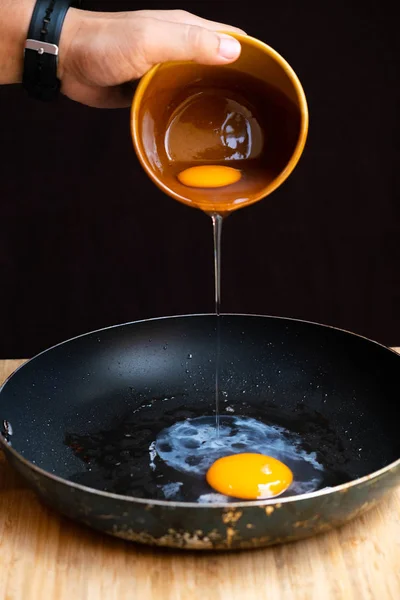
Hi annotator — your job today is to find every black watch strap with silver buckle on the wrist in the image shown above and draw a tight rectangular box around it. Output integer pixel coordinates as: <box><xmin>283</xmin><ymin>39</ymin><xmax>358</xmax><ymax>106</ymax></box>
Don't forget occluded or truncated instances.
<box><xmin>22</xmin><ymin>0</ymin><xmax>75</xmax><ymax>101</ymax></box>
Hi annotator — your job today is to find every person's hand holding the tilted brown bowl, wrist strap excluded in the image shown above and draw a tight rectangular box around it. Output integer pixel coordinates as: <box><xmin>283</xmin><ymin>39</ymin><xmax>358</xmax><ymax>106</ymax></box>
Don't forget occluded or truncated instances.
<box><xmin>58</xmin><ymin>9</ymin><xmax>244</xmax><ymax>108</ymax></box>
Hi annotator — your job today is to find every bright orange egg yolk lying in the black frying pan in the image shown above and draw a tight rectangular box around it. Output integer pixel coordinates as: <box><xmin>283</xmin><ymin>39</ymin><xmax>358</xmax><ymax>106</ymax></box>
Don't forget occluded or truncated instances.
<box><xmin>206</xmin><ymin>452</ymin><xmax>293</xmax><ymax>500</ymax></box>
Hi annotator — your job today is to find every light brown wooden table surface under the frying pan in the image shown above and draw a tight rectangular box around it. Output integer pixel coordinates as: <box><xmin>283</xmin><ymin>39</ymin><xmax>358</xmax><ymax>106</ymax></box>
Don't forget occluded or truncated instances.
<box><xmin>0</xmin><ymin>356</ymin><xmax>400</xmax><ymax>600</ymax></box>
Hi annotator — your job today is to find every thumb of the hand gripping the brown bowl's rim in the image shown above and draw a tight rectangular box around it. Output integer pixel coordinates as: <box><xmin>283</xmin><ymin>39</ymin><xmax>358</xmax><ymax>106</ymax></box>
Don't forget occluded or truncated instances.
<box><xmin>142</xmin><ymin>19</ymin><xmax>241</xmax><ymax>66</ymax></box>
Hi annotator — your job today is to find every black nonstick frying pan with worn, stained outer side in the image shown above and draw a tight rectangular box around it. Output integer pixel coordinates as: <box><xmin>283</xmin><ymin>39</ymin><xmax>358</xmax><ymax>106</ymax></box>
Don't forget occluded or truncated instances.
<box><xmin>0</xmin><ymin>315</ymin><xmax>400</xmax><ymax>549</ymax></box>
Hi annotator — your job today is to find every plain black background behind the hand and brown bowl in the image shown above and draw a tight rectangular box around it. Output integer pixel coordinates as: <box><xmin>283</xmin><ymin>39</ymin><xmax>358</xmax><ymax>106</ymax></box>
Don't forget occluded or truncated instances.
<box><xmin>0</xmin><ymin>0</ymin><xmax>400</xmax><ymax>358</ymax></box>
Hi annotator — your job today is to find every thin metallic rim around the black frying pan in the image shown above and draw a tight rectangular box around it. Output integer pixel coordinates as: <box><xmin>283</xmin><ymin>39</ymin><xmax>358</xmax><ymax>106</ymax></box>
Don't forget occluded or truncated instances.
<box><xmin>0</xmin><ymin>313</ymin><xmax>400</xmax><ymax>510</ymax></box>
